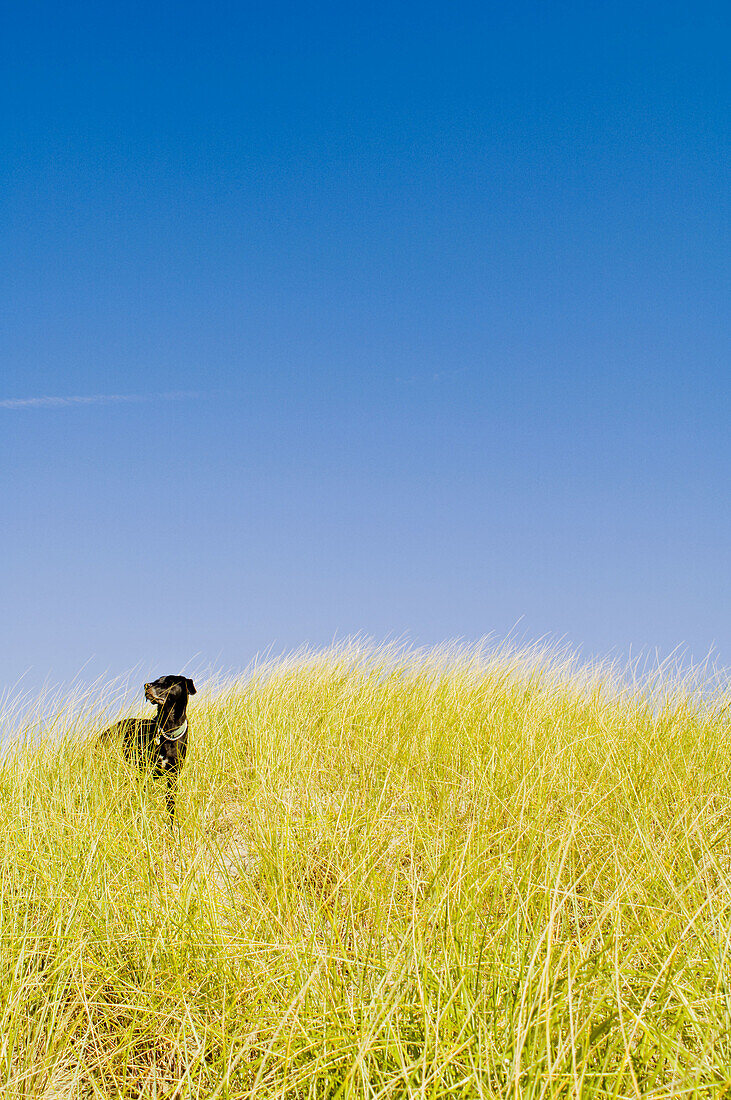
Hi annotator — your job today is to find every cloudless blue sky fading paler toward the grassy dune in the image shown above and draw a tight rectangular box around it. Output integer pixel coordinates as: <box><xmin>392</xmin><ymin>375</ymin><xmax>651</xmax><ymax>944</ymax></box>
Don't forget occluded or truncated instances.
<box><xmin>0</xmin><ymin>0</ymin><xmax>731</xmax><ymax>685</ymax></box>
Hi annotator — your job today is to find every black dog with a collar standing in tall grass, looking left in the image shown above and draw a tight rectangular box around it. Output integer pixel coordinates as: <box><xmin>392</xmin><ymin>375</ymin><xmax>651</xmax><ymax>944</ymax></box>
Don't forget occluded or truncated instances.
<box><xmin>101</xmin><ymin>677</ymin><xmax>196</xmax><ymax>822</ymax></box>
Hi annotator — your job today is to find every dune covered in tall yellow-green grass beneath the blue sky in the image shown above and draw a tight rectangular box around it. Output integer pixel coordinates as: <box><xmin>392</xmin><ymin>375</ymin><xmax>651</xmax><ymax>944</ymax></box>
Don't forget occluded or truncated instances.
<box><xmin>0</xmin><ymin>649</ymin><xmax>731</xmax><ymax>1098</ymax></box>
